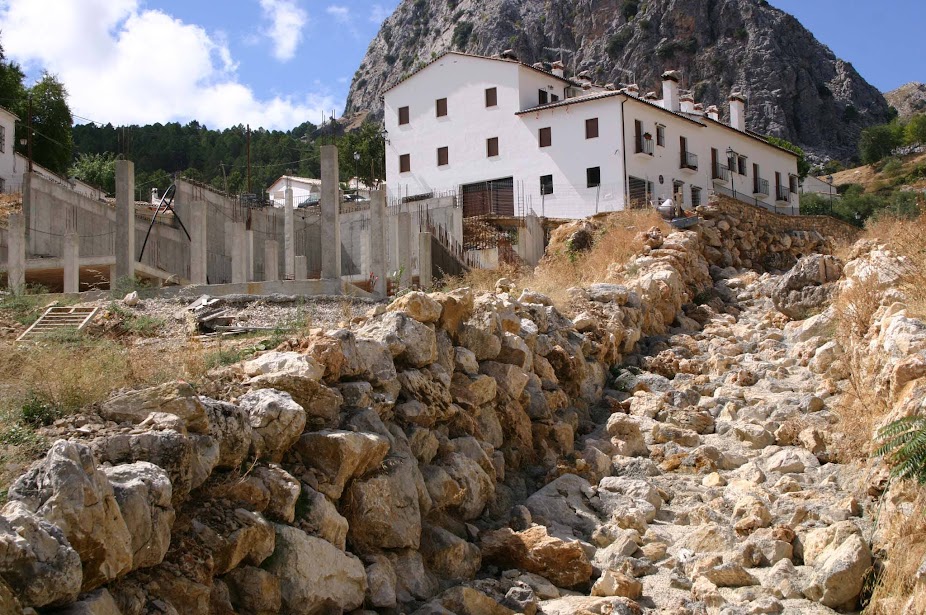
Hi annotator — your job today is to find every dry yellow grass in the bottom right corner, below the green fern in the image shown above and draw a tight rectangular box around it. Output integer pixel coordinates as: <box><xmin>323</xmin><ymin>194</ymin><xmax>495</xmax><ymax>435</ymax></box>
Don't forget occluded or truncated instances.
<box><xmin>866</xmin><ymin>483</ymin><xmax>926</xmax><ymax>615</ymax></box>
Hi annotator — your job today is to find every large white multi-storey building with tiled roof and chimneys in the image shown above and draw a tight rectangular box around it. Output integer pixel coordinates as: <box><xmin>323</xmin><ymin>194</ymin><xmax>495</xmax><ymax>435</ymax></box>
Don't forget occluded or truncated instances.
<box><xmin>384</xmin><ymin>52</ymin><xmax>798</xmax><ymax>218</ymax></box>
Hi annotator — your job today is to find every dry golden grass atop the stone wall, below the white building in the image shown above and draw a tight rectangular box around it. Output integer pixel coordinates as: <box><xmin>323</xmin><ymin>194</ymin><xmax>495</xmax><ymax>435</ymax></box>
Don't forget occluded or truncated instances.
<box><xmin>445</xmin><ymin>210</ymin><xmax>670</xmax><ymax>312</ymax></box>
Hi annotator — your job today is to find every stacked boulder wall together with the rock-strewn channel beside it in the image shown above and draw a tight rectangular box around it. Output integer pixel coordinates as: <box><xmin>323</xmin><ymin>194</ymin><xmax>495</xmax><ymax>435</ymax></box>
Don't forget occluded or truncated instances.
<box><xmin>0</xmin><ymin>213</ymin><xmax>899</xmax><ymax>615</ymax></box>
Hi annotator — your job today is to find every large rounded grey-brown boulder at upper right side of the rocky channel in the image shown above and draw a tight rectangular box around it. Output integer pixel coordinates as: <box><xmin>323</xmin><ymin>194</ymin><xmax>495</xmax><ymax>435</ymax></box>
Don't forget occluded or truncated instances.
<box><xmin>772</xmin><ymin>254</ymin><xmax>842</xmax><ymax>320</ymax></box>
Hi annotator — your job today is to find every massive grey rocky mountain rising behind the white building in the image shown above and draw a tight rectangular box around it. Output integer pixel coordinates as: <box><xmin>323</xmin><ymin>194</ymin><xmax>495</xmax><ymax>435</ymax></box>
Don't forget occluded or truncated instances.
<box><xmin>345</xmin><ymin>0</ymin><xmax>890</xmax><ymax>159</ymax></box>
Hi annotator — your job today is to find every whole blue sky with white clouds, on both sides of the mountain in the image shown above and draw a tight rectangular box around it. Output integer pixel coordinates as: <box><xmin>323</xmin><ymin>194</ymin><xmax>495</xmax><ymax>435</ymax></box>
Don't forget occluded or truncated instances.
<box><xmin>0</xmin><ymin>0</ymin><xmax>926</xmax><ymax>130</ymax></box>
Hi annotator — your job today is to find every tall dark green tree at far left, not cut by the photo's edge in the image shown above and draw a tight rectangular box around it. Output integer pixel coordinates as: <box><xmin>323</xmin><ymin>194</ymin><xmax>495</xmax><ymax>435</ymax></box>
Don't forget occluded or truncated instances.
<box><xmin>17</xmin><ymin>73</ymin><xmax>74</xmax><ymax>175</ymax></box>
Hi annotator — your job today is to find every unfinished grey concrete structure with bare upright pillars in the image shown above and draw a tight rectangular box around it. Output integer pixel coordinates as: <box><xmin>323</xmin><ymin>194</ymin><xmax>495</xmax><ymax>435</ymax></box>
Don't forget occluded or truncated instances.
<box><xmin>0</xmin><ymin>147</ymin><xmax>478</xmax><ymax>296</ymax></box>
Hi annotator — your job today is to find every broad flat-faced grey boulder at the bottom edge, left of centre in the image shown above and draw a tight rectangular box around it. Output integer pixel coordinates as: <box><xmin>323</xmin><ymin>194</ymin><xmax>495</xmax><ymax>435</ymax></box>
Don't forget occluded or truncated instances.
<box><xmin>264</xmin><ymin>525</ymin><xmax>367</xmax><ymax>615</ymax></box>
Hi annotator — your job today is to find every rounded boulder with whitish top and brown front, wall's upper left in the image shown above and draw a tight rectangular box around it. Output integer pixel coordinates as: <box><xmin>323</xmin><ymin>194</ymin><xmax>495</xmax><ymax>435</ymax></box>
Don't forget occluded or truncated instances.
<box><xmin>239</xmin><ymin>389</ymin><xmax>306</xmax><ymax>462</ymax></box>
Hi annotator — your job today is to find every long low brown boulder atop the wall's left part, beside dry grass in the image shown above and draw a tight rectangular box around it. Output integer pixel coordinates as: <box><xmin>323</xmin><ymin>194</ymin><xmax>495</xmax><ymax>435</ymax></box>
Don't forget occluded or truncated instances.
<box><xmin>100</xmin><ymin>381</ymin><xmax>209</xmax><ymax>434</ymax></box>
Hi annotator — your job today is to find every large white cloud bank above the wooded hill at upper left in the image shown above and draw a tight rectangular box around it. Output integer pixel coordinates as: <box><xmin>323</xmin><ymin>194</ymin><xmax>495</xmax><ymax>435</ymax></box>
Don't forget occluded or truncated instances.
<box><xmin>0</xmin><ymin>0</ymin><xmax>341</xmax><ymax>130</ymax></box>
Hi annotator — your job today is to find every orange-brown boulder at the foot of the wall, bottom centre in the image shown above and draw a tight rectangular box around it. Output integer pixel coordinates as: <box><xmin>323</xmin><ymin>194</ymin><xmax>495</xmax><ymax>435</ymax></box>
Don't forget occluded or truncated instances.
<box><xmin>480</xmin><ymin>525</ymin><xmax>592</xmax><ymax>587</ymax></box>
